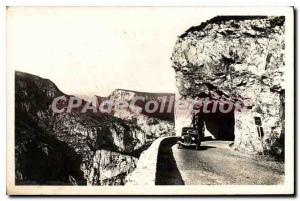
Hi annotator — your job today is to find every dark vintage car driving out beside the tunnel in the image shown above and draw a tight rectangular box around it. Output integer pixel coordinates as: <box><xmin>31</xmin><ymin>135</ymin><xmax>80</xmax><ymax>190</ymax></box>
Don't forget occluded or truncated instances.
<box><xmin>177</xmin><ymin>127</ymin><xmax>201</xmax><ymax>150</ymax></box>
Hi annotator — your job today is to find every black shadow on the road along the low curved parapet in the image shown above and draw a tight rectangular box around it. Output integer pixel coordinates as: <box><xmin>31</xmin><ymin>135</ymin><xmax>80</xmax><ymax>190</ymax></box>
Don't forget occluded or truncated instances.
<box><xmin>155</xmin><ymin>139</ymin><xmax>184</xmax><ymax>185</ymax></box>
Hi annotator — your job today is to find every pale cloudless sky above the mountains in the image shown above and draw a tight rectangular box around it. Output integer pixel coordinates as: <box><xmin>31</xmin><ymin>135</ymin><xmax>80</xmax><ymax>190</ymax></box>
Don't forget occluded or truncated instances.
<box><xmin>7</xmin><ymin>7</ymin><xmax>213</xmax><ymax>96</ymax></box>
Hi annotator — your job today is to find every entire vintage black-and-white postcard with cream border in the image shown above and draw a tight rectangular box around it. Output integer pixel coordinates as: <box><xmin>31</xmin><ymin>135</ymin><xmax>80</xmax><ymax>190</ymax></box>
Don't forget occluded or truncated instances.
<box><xmin>6</xmin><ymin>7</ymin><xmax>294</xmax><ymax>195</ymax></box>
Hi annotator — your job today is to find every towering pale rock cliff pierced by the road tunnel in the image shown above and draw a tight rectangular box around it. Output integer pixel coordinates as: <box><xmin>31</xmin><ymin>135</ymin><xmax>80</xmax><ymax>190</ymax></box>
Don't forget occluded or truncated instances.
<box><xmin>172</xmin><ymin>16</ymin><xmax>285</xmax><ymax>156</ymax></box>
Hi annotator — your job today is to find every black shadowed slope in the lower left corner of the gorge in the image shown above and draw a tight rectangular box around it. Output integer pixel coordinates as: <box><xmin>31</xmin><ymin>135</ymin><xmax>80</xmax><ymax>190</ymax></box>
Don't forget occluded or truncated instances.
<box><xmin>16</xmin><ymin>115</ymin><xmax>86</xmax><ymax>185</ymax></box>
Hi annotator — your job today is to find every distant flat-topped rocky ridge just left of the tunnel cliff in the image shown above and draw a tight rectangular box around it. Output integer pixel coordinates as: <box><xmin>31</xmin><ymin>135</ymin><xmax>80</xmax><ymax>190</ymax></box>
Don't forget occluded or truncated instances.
<box><xmin>109</xmin><ymin>89</ymin><xmax>175</xmax><ymax>142</ymax></box>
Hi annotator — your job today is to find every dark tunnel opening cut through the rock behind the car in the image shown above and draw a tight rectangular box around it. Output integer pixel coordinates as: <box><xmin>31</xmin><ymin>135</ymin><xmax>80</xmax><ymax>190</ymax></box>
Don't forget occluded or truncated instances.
<box><xmin>193</xmin><ymin>111</ymin><xmax>235</xmax><ymax>141</ymax></box>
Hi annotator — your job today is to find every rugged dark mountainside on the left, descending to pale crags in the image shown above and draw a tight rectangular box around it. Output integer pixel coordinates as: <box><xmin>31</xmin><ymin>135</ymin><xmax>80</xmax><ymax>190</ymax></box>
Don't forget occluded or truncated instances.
<box><xmin>15</xmin><ymin>72</ymin><xmax>176</xmax><ymax>185</ymax></box>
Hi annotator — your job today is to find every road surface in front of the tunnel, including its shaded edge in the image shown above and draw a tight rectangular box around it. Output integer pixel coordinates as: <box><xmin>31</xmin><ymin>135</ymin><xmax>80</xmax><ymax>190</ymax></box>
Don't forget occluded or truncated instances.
<box><xmin>156</xmin><ymin>141</ymin><xmax>284</xmax><ymax>185</ymax></box>
